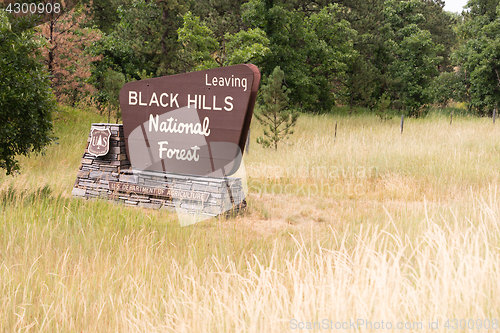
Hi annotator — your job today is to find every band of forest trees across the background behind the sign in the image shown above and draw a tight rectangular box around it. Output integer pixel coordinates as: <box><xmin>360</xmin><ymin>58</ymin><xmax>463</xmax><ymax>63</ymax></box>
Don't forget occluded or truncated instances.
<box><xmin>3</xmin><ymin>0</ymin><xmax>500</xmax><ymax>117</ymax></box>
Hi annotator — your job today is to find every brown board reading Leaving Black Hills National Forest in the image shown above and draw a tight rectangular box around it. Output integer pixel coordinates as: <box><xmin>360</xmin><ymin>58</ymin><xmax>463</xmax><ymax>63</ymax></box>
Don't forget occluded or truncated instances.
<box><xmin>120</xmin><ymin>64</ymin><xmax>260</xmax><ymax>176</ymax></box>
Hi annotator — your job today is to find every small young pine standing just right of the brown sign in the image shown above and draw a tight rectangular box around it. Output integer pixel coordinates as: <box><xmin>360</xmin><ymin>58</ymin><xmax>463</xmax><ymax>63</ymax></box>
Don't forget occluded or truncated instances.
<box><xmin>255</xmin><ymin>67</ymin><xmax>299</xmax><ymax>149</ymax></box>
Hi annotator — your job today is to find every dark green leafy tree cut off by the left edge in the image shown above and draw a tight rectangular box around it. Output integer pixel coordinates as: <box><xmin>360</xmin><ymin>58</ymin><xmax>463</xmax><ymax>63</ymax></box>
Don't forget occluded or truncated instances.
<box><xmin>0</xmin><ymin>11</ymin><xmax>56</xmax><ymax>174</ymax></box>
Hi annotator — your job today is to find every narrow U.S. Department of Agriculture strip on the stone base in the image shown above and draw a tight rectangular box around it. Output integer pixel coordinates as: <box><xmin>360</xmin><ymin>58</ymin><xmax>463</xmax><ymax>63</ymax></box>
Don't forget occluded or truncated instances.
<box><xmin>108</xmin><ymin>182</ymin><xmax>210</xmax><ymax>201</ymax></box>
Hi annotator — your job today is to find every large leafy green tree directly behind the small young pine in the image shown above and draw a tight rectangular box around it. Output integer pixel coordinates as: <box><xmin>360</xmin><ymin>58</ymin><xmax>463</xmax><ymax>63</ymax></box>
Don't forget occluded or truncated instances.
<box><xmin>243</xmin><ymin>0</ymin><xmax>357</xmax><ymax>112</ymax></box>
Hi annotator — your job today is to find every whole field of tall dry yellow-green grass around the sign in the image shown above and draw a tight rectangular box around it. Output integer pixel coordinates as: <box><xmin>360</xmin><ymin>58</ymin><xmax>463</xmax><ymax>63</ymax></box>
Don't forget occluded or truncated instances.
<box><xmin>0</xmin><ymin>109</ymin><xmax>500</xmax><ymax>332</ymax></box>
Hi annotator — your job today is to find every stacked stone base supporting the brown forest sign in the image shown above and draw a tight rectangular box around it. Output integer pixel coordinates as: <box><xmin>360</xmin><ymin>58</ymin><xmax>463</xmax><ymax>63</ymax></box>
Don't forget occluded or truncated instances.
<box><xmin>72</xmin><ymin>124</ymin><xmax>246</xmax><ymax>216</ymax></box>
